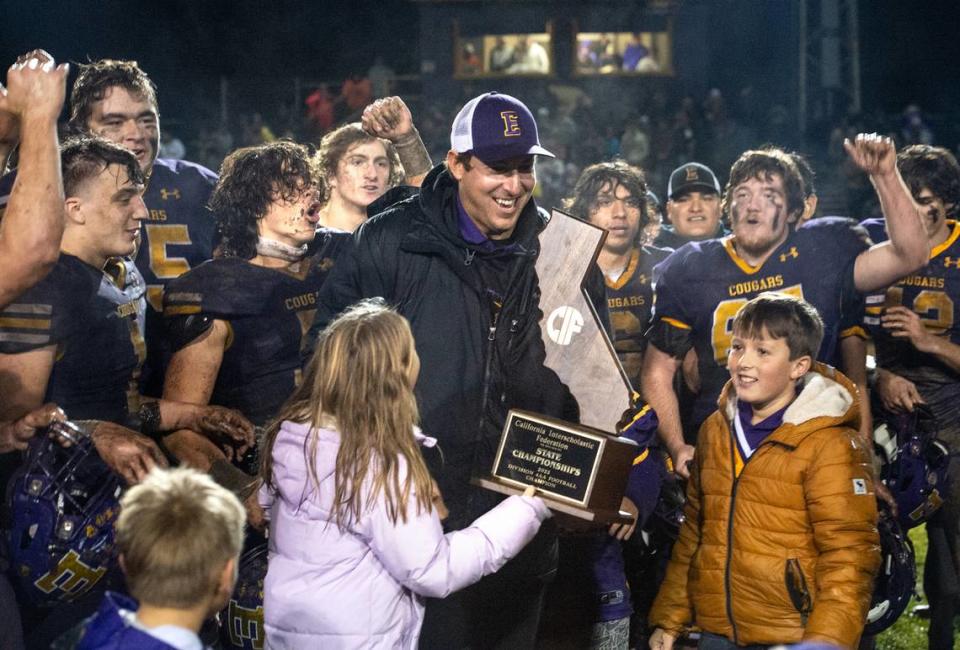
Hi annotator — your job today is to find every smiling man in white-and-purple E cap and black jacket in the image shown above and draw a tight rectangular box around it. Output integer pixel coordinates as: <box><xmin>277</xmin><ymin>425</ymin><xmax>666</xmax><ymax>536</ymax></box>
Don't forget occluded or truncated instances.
<box><xmin>308</xmin><ymin>93</ymin><xmax>576</xmax><ymax>648</ymax></box>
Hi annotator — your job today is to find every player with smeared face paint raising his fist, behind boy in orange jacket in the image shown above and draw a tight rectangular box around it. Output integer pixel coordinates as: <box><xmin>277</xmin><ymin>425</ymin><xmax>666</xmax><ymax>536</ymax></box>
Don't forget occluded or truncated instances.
<box><xmin>641</xmin><ymin>135</ymin><xmax>928</xmax><ymax>476</ymax></box>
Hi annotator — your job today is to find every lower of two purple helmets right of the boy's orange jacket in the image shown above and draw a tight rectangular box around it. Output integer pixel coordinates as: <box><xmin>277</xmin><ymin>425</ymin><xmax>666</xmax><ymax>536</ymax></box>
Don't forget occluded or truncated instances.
<box><xmin>863</xmin><ymin>513</ymin><xmax>917</xmax><ymax>634</ymax></box>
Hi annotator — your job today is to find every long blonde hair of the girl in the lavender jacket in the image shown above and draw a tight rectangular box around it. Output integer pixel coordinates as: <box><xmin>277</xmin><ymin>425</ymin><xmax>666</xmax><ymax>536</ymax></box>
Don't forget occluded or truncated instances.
<box><xmin>260</xmin><ymin>300</ymin><xmax>432</xmax><ymax>528</ymax></box>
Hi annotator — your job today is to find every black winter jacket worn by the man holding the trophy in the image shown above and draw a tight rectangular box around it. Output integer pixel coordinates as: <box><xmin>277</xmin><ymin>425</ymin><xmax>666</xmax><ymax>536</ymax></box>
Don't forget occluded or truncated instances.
<box><xmin>307</xmin><ymin>165</ymin><xmax>605</xmax><ymax>529</ymax></box>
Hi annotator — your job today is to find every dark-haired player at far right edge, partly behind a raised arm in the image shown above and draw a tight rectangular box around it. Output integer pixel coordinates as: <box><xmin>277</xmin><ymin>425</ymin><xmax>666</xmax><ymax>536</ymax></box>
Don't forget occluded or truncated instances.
<box><xmin>863</xmin><ymin>145</ymin><xmax>960</xmax><ymax>648</ymax></box>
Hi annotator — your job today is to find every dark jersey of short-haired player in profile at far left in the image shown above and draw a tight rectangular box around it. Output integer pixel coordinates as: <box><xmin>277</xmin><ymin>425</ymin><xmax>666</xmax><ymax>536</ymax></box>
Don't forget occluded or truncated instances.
<box><xmin>0</xmin><ymin>253</ymin><xmax>146</xmax><ymax>423</ymax></box>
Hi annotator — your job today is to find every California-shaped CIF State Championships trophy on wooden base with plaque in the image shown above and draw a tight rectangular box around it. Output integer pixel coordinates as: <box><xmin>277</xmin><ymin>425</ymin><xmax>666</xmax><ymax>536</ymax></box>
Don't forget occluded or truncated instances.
<box><xmin>474</xmin><ymin>210</ymin><xmax>639</xmax><ymax>524</ymax></box>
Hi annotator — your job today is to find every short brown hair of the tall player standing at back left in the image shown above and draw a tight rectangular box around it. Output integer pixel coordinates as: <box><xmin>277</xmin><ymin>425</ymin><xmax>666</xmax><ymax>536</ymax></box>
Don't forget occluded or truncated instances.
<box><xmin>70</xmin><ymin>59</ymin><xmax>159</xmax><ymax>128</ymax></box>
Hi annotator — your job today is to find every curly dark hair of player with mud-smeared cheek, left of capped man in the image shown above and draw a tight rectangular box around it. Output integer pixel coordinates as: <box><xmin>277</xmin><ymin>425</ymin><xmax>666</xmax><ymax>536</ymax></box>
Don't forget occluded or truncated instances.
<box><xmin>210</xmin><ymin>140</ymin><xmax>326</xmax><ymax>260</ymax></box>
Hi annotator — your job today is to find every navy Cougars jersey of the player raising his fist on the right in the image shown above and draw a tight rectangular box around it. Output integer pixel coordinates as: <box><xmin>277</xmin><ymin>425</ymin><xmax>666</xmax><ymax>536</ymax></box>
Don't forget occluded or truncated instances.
<box><xmin>648</xmin><ymin>217</ymin><xmax>870</xmax><ymax>434</ymax></box>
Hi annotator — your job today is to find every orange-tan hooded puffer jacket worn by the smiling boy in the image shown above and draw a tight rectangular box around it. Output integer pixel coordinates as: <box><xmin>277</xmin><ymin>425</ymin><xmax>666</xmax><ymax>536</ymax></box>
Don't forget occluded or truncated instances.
<box><xmin>649</xmin><ymin>364</ymin><xmax>880</xmax><ymax>648</ymax></box>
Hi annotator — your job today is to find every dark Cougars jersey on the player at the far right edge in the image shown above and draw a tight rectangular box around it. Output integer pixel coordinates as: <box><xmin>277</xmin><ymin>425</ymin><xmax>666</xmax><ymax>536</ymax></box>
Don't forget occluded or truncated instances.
<box><xmin>863</xmin><ymin>219</ymin><xmax>960</xmax><ymax>390</ymax></box>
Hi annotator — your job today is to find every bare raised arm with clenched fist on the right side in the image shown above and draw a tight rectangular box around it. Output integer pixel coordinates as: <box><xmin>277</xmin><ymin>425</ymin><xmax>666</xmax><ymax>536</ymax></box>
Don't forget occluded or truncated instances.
<box><xmin>843</xmin><ymin>133</ymin><xmax>930</xmax><ymax>291</ymax></box>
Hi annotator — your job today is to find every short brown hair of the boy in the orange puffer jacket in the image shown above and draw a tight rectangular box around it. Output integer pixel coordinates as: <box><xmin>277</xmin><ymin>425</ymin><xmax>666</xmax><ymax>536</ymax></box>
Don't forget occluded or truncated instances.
<box><xmin>733</xmin><ymin>291</ymin><xmax>823</xmax><ymax>361</ymax></box>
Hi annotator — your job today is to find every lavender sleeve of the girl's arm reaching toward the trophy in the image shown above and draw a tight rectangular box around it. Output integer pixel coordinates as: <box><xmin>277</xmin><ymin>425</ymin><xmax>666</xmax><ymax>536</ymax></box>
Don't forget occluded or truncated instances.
<box><xmin>360</xmin><ymin>494</ymin><xmax>549</xmax><ymax>598</ymax></box>
